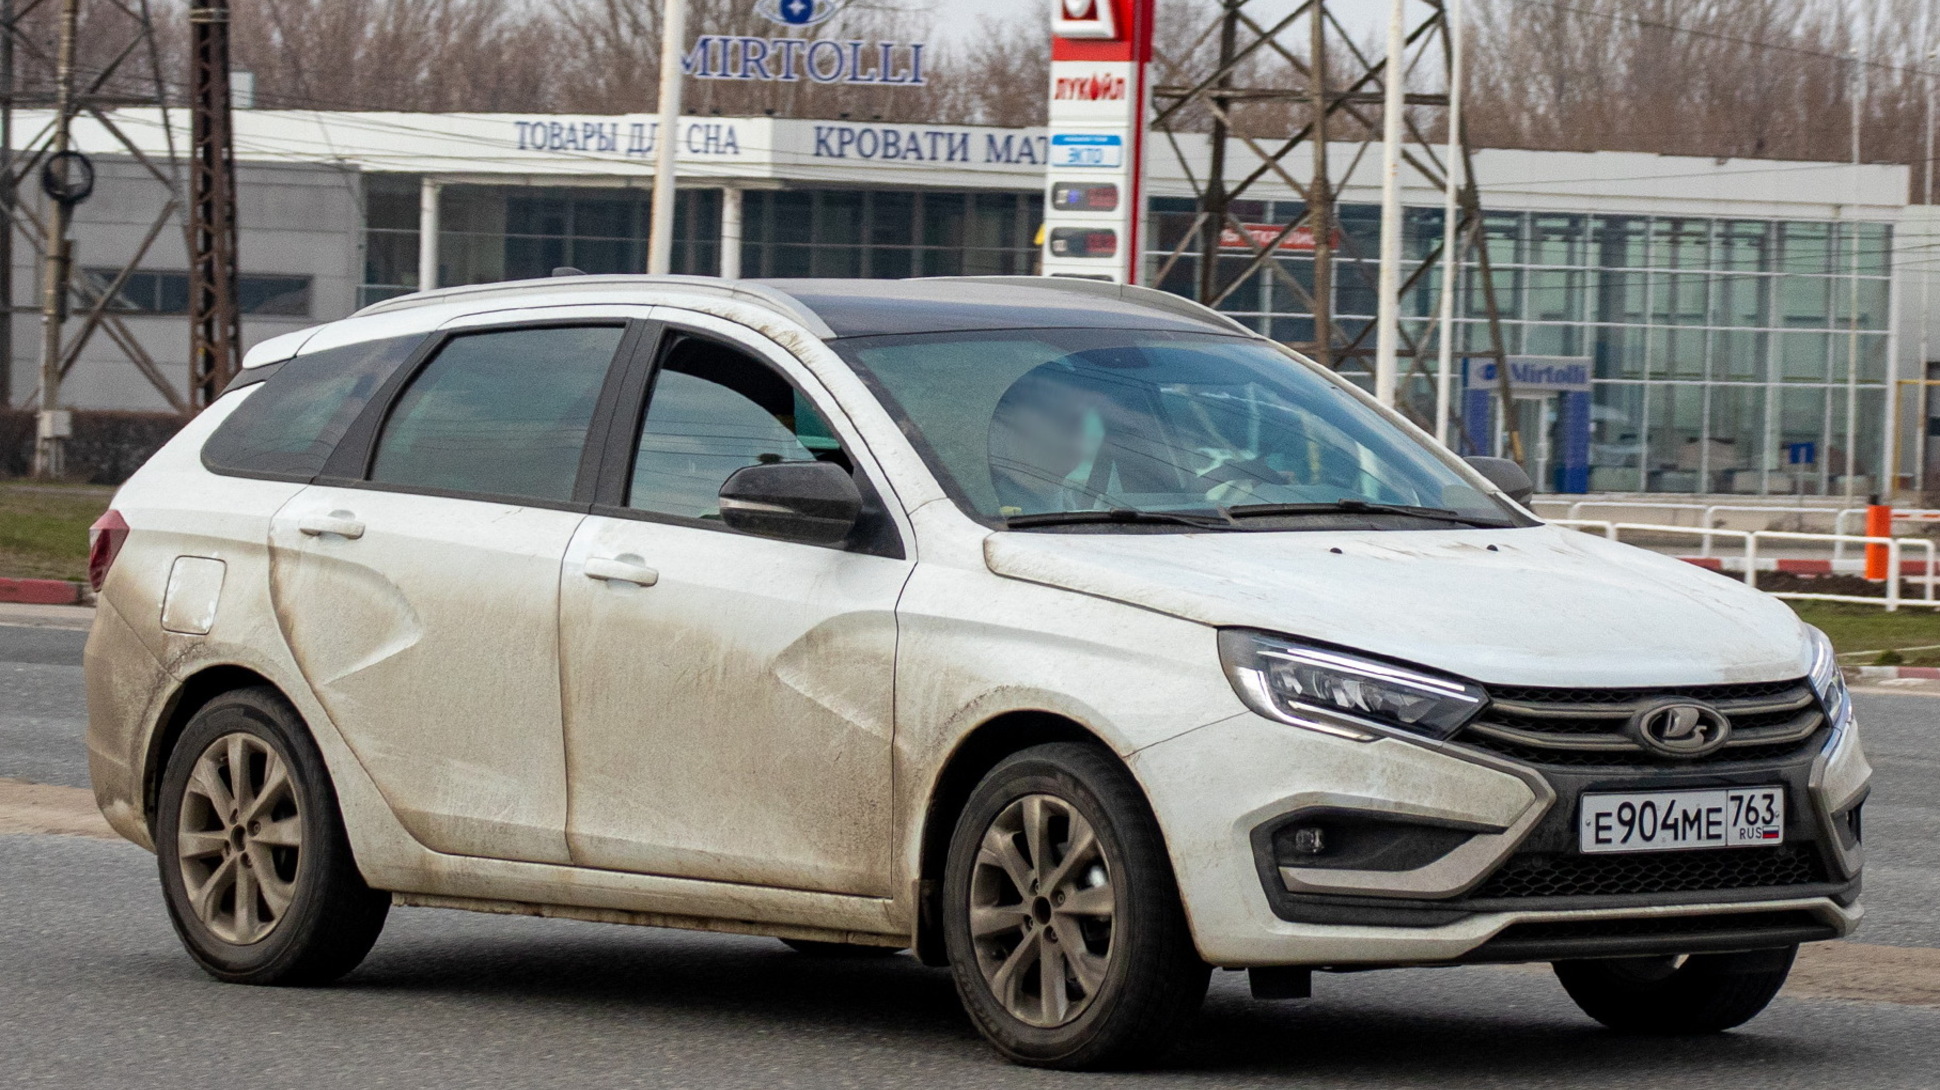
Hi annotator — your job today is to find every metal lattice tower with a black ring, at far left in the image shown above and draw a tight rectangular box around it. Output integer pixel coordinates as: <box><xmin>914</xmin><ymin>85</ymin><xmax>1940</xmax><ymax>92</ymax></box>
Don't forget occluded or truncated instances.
<box><xmin>0</xmin><ymin>0</ymin><xmax>188</xmax><ymax>475</ymax></box>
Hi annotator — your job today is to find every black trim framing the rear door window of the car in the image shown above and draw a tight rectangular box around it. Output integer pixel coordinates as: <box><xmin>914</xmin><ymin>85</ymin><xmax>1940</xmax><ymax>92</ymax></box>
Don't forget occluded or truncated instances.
<box><xmin>310</xmin><ymin>314</ymin><xmax>650</xmax><ymax>514</ymax></box>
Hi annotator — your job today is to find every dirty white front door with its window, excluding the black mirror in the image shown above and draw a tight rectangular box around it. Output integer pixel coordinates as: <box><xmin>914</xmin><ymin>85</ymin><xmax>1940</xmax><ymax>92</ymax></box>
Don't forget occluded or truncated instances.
<box><xmin>559</xmin><ymin>321</ymin><xmax>910</xmax><ymax>896</ymax></box>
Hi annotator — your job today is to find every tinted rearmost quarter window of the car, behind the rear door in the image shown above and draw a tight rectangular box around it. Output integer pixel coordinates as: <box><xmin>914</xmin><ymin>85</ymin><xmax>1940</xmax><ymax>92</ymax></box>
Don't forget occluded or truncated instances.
<box><xmin>202</xmin><ymin>336</ymin><xmax>423</xmax><ymax>481</ymax></box>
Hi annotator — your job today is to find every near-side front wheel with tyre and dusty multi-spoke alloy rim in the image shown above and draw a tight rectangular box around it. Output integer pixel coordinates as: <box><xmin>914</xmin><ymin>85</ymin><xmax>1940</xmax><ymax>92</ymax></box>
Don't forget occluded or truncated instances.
<box><xmin>943</xmin><ymin>743</ymin><xmax>1211</xmax><ymax>1071</ymax></box>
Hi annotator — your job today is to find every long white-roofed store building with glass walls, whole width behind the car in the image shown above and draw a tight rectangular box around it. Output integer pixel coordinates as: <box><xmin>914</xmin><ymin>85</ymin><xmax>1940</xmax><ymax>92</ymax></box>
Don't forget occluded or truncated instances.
<box><xmin>16</xmin><ymin>111</ymin><xmax>1916</xmax><ymax>495</ymax></box>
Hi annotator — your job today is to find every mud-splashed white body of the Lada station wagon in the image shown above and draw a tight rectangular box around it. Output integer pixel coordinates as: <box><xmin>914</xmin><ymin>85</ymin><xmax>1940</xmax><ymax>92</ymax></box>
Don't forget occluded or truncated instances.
<box><xmin>87</xmin><ymin>277</ymin><xmax>1868</xmax><ymax>1061</ymax></box>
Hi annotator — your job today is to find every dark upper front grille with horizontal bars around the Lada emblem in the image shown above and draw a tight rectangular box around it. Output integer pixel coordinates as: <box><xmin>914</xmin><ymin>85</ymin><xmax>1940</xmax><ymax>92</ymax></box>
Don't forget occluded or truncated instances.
<box><xmin>1459</xmin><ymin>679</ymin><xmax>1826</xmax><ymax>768</ymax></box>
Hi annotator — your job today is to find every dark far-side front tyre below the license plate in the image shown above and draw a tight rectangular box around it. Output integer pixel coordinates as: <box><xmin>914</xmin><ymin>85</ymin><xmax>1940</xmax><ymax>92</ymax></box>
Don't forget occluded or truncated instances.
<box><xmin>1554</xmin><ymin>946</ymin><xmax>1798</xmax><ymax>1036</ymax></box>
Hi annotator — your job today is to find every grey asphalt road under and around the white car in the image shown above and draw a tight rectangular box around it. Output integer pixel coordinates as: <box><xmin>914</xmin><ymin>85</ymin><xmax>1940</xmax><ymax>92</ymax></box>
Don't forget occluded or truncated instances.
<box><xmin>0</xmin><ymin>626</ymin><xmax>1940</xmax><ymax>1090</ymax></box>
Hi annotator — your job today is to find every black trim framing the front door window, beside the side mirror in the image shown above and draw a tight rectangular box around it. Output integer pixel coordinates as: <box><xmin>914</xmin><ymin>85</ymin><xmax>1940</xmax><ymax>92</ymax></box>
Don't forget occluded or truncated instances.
<box><xmin>588</xmin><ymin>312</ymin><xmax>910</xmax><ymax>561</ymax></box>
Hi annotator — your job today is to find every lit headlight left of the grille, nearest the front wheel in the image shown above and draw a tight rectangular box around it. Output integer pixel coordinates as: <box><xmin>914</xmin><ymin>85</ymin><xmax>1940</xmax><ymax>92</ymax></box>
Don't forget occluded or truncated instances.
<box><xmin>1218</xmin><ymin>628</ymin><xmax>1488</xmax><ymax>741</ymax></box>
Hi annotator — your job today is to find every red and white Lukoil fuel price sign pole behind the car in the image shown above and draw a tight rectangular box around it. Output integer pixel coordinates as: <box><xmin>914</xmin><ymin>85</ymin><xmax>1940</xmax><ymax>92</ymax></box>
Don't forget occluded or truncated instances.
<box><xmin>1044</xmin><ymin>0</ymin><xmax>1154</xmax><ymax>283</ymax></box>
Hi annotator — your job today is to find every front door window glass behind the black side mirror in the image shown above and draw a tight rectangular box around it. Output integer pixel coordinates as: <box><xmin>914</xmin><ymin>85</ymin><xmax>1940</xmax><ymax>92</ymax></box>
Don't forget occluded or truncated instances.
<box><xmin>627</xmin><ymin>336</ymin><xmax>852</xmax><ymax>520</ymax></box>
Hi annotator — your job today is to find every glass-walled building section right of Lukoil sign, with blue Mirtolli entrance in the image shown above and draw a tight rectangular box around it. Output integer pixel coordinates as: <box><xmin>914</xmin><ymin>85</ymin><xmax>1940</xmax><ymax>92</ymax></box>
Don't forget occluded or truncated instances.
<box><xmin>1148</xmin><ymin>151</ymin><xmax>1901</xmax><ymax>495</ymax></box>
